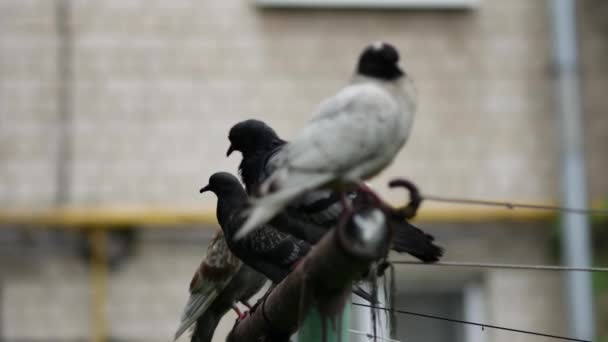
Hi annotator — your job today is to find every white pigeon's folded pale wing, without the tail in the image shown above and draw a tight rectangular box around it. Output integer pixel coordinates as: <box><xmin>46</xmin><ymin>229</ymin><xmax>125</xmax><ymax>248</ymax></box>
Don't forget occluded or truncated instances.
<box><xmin>279</xmin><ymin>83</ymin><xmax>399</xmax><ymax>174</ymax></box>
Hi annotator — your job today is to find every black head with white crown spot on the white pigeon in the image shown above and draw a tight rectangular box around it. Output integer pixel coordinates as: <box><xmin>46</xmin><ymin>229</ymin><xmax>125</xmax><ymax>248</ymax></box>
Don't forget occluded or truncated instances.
<box><xmin>357</xmin><ymin>42</ymin><xmax>404</xmax><ymax>81</ymax></box>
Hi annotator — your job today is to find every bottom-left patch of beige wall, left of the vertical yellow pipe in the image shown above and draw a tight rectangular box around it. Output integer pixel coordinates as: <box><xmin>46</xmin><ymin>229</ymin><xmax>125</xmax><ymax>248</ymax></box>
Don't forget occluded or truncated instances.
<box><xmin>0</xmin><ymin>250</ymin><xmax>91</xmax><ymax>341</ymax></box>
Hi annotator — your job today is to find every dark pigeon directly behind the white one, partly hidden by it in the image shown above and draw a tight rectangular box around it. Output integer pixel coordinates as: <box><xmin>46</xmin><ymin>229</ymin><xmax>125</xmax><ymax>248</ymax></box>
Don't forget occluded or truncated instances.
<box><xmin>228</xmin><ymin>119</ymin><xmax>443</xmax><ymax>262</ymax></box>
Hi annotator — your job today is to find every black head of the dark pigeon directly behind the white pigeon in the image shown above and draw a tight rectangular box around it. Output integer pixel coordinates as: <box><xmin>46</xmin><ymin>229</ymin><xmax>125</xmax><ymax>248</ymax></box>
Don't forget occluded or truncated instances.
<box><xmin>226</xmin><ymin>119</ymin><xmax>285</xmax><ymax>156</ymax></box>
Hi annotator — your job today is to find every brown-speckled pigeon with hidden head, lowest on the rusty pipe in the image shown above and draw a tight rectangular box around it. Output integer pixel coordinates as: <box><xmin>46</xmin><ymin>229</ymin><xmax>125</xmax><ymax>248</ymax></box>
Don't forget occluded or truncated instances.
<box><xmin>175</xmin><ymin>231</ymin><xmax>267</xmax><ymax>342</ymax></box>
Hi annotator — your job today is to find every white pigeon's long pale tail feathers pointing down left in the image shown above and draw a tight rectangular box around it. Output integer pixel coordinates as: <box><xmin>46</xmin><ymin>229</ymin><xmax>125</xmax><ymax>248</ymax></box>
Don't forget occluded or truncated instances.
<box><xmin>234</xmin><ymin>173</ymin><xmax>332</xmax><ymax>240</ymax></box>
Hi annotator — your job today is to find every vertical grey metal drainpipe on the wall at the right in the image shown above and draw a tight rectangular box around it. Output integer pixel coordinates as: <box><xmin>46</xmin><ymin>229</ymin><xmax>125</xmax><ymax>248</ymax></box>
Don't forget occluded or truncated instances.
<box><xmin>548</xmin><ymin>0</ymin><xmax>594</xmax><ymax>340</ymax></box>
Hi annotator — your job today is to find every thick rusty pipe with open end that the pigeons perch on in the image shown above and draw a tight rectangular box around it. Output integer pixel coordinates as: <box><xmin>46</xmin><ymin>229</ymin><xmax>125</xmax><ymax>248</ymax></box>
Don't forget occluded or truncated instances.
<box><xmin>227</xmin><ymin>208</ymin><xmax>390</xmax><ymax>342</ymax></box>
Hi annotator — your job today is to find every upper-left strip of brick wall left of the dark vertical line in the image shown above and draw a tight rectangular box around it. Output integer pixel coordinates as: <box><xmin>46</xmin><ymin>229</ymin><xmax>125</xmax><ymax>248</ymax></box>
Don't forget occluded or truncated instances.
<box><xmin>0</xmin><ymin>0</ymin><xmax>57</xmax><ymax>207</ymax></box>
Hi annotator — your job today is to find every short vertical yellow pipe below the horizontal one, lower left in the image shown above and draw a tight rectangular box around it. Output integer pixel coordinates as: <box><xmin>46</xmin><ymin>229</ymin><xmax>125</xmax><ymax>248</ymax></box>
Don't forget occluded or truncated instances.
<box><xmin>89</xmin><ymin>228</ymin><xmax>108</xmax><ymax>342</ymax></box>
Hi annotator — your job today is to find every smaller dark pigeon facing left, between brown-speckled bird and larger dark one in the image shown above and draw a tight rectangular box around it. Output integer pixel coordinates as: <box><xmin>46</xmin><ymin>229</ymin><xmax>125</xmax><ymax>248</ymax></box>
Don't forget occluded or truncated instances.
<box><xmin>200</xmin><ymin>172</ymin><xmax>371</xmax><ymax>300</ymax></box>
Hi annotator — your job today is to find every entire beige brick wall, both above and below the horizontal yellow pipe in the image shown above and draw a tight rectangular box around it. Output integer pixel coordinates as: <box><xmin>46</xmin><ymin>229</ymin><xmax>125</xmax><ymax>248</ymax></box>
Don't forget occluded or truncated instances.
<box><xmin>0</xmin><ymin>0</ymin><xmax>608</xmax><ymax>341</ymax></box>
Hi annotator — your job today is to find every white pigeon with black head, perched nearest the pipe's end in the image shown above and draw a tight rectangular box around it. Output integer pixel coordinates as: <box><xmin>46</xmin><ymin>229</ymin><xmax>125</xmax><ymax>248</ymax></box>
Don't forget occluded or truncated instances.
<box><xmin>235</xmin><ymin>42</ymin><xmax>416</xmax><ymax>239</ymax></box>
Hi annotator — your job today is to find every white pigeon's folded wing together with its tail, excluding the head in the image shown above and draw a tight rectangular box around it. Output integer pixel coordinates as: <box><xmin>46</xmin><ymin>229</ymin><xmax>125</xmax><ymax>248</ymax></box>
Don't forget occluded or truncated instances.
<box><xmin>235</xmin><ymin>83</ymin><xmax>400</xmax><ymax>239</ymax></box>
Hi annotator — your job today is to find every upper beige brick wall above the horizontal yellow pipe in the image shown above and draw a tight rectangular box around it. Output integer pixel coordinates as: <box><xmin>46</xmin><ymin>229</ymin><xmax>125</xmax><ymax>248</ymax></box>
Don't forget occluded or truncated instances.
<box><xmin>0</xmin><ymin>0</ymin><xmax>608</xmax><ymax>207</ymax></box>
